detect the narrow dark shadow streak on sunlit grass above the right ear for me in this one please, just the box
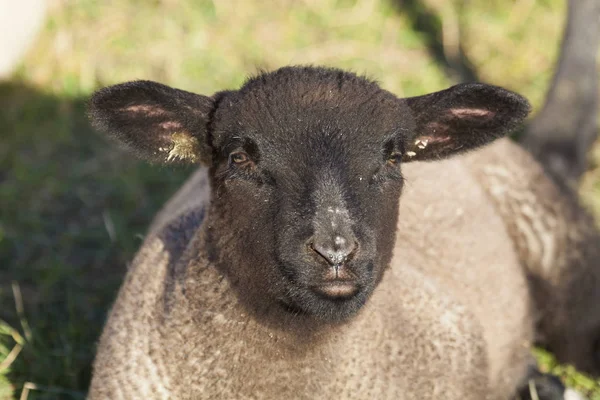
[392,0,479,82]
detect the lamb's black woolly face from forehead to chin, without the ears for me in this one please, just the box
[212,73,414,320]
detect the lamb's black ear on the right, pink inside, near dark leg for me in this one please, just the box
[402,83,530,162]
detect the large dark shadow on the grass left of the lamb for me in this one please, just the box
[0,82,190,400]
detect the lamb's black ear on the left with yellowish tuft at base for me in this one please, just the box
[88,81,213,164]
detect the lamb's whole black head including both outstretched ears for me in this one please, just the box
[90,67,529,321]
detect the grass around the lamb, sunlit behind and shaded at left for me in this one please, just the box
[0,0,600,399]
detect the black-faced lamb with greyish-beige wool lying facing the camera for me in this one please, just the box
[84,66,560,400]
